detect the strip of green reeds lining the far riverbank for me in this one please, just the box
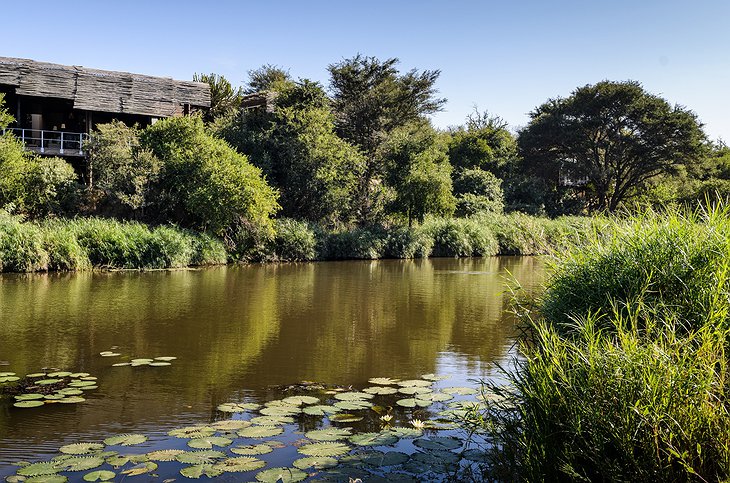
[0,213,605,272]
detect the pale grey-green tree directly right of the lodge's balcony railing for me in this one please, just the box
[87,121,162,218]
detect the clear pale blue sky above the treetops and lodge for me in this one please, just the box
[5,0,730,142]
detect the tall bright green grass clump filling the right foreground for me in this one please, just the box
[474,209,730,481]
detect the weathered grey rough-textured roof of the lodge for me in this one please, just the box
[0,57,210,117]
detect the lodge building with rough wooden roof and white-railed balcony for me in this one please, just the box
[0,57,210,158]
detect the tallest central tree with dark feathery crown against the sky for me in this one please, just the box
[328,54,446,222]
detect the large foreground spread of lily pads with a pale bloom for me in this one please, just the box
[8,374,487,483]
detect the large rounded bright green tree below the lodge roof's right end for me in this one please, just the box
[140,117,279,240]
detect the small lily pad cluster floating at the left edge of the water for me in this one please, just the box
[0,370,98,408]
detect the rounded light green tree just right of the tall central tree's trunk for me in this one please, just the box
[384,122,455,226]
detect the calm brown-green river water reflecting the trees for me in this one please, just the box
[0,257,543,475]
